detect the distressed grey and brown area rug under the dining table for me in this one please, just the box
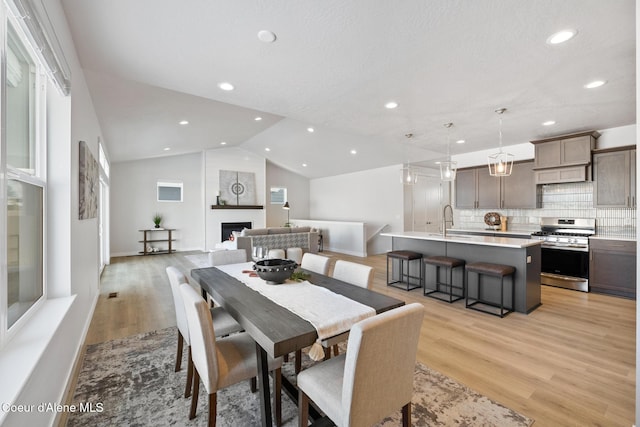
[67,327,533,427]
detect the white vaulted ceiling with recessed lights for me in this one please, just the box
[62,0,636,178]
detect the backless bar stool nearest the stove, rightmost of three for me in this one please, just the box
[465,262,516,317]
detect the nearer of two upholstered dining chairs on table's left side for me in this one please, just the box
[180,284,282,426]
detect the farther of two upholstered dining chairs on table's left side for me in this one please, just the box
[166,266,242,397]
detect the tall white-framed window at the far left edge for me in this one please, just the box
[0,13,46,336]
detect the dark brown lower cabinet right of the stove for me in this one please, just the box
[589,239,636,299]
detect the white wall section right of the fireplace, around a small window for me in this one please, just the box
[265,161,309,227]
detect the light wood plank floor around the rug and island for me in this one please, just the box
[80,252,635,427]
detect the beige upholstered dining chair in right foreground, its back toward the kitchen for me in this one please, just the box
[297,303,424,427]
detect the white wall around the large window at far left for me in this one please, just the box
[2,0,101,426]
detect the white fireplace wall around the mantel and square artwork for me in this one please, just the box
[204,148,266,250]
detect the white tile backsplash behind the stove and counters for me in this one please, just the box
[454,181,636,237]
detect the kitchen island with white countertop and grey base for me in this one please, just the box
[381,231,542,314]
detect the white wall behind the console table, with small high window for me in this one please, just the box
[110,153,204,256]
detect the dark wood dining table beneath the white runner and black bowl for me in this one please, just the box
[191,267,404,426]
